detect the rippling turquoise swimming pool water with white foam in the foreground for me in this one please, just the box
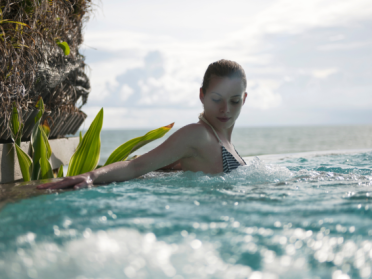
[0,151,372,279]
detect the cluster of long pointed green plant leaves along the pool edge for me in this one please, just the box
[10,97,174,181]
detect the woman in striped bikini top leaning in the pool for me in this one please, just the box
[38,60,247,189]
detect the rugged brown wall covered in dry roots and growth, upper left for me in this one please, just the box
[0,0,92,142]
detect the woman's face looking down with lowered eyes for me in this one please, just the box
[200,76,247,128]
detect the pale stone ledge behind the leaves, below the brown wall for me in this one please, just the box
[0,137,79,184]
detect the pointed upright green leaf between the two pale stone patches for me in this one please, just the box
[31,125,53,180]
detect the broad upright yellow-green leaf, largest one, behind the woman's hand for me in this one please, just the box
[66,108,103,176]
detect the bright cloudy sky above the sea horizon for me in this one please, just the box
[80,0,372,129]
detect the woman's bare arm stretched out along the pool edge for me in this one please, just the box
[37,125,196,189]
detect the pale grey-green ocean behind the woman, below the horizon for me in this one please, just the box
[99,125,372,164]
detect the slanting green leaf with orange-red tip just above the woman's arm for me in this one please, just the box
[105,123,174,166]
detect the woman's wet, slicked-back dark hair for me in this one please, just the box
[202,59,247,94]
